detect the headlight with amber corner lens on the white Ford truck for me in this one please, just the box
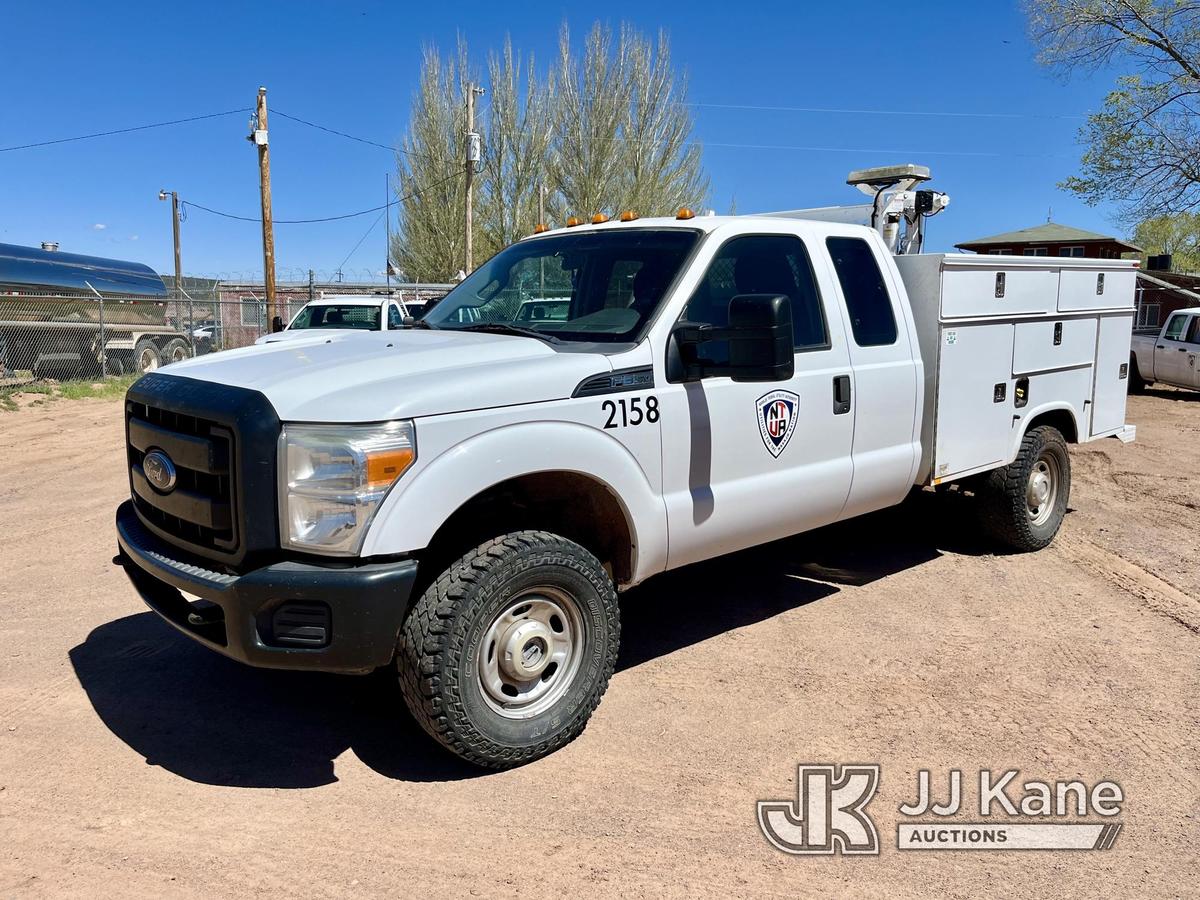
[280,421,416,556]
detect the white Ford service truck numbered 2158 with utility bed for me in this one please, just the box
[116,166,1135,768]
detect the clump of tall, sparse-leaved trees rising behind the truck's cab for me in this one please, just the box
[392,24,708,281]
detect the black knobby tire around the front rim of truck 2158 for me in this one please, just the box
[396,530,620,769]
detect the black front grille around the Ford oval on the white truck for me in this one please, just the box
[126,400,239,553]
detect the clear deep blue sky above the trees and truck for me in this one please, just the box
[0,0,1116,277]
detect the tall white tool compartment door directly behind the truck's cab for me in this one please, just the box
[932,323,1013,479]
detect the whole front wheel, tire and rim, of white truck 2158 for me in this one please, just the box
[396,532,620,769]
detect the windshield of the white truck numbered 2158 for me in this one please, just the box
[425,228,700,341]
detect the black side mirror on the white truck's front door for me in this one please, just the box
[667,294,796,382]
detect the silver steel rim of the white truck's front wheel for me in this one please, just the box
[476,586,583,719]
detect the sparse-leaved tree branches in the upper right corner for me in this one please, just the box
[1025,0,1200,222]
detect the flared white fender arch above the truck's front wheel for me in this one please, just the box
[362,421,667,582]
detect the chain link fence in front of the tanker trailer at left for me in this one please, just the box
[0,278,452,389]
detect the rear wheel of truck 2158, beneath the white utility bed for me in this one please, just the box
[980,425,1070,552]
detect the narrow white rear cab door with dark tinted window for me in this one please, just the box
[826,235,922,518]
